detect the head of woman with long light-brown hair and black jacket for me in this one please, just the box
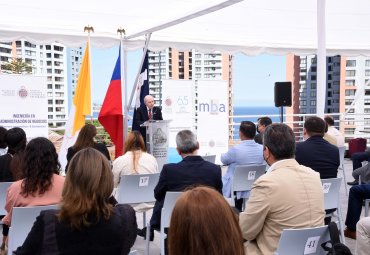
[59,148,113,229]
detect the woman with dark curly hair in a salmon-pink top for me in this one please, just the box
[3,137,64,226]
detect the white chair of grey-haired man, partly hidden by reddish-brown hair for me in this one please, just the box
[159,191,182,254]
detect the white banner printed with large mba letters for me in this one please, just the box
[197,81,229,163]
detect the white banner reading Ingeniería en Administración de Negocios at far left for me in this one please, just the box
[0,75,48,140]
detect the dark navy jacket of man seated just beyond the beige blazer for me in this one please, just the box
[295,136,339,179]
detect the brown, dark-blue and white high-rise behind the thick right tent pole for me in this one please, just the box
[286,55,370,142]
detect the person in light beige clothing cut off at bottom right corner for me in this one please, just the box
[355,217,370,255]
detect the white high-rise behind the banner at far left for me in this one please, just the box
[0,40,82,127]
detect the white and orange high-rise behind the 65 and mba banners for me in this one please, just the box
[148,48,233,138]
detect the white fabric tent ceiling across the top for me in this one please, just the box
[0,0,370,55]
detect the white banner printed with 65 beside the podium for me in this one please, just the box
[162,80,195,148]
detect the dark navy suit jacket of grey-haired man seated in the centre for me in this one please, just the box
[150,156,222,228]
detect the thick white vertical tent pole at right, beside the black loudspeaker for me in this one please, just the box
[316,0,326,117]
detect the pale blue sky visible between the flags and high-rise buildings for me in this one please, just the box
[91,47,286,106]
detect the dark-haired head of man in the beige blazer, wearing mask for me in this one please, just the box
[263,123,295,165]
